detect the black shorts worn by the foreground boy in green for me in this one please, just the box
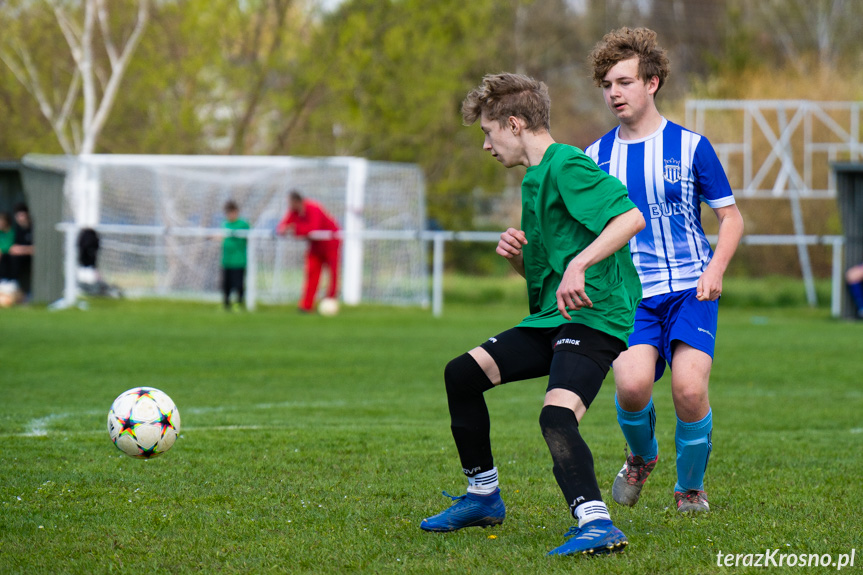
[480,323,626,406]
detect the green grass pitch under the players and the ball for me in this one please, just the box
[0,281,863,574]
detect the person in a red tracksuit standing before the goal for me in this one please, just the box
[276,190,341,311]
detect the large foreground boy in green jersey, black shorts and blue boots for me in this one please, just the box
[420,74,645,555]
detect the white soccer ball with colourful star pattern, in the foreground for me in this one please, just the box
[108,387,180,459]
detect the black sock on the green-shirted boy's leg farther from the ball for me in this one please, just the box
[539,405,602,517]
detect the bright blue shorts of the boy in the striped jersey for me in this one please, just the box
[629,288,719,381]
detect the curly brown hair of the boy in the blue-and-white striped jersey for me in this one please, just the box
[588,27,669,92]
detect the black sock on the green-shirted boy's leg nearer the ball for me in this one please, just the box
[444,353,494,477]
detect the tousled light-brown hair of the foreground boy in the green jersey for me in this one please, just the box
[461,73,551,132]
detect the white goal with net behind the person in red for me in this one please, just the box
[28,155,429,307]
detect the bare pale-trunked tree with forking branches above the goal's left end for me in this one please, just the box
[0,0,150,154]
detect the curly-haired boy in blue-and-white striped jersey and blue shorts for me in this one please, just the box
[585,28,743,512]
